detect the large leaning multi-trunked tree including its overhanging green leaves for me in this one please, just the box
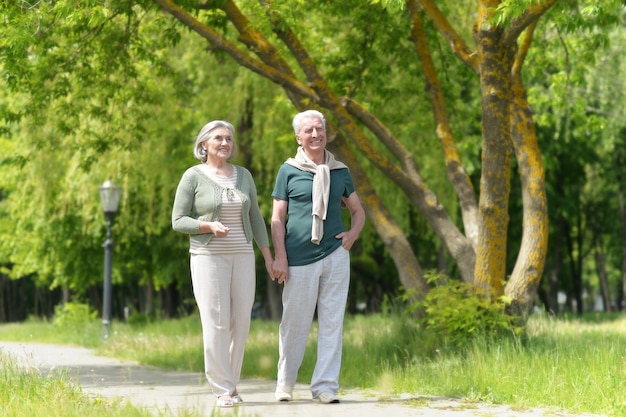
[2,0,620,315]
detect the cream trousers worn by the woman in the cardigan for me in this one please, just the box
[190,253,256,397]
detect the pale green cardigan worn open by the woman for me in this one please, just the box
[172,165,269,248]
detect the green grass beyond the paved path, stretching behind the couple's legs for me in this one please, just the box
[0,314,626,416]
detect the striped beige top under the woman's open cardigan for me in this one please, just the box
[189,164,254,255]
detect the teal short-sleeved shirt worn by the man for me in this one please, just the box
[272,164,354,266]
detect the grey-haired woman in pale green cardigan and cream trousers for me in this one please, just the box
[172,120,272,407]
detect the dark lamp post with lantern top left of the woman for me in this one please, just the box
[100,181,122,340]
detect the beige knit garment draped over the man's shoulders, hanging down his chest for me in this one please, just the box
[285,146,347,245]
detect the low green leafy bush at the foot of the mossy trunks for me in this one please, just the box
[403,272,523,350]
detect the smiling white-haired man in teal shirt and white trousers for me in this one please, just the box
[271,110,365,404]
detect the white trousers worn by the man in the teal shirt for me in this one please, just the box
[277,246,350,398]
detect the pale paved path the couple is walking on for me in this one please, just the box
[0,341,598,417]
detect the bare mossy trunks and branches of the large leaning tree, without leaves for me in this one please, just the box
[147,0,555,314]
